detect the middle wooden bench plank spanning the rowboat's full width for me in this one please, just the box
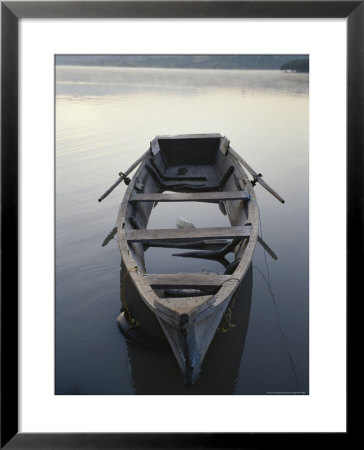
[125,226,251,242]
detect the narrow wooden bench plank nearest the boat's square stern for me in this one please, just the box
[130,191,249,202]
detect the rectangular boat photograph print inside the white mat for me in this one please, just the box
[55,54,309,395]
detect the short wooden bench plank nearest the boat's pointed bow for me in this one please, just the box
[143,273,232,289]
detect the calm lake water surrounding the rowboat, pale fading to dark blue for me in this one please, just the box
[56,66,309,395]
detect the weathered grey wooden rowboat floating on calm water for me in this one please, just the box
[111,134,282,385]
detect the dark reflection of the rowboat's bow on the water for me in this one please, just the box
[122,266,252,395]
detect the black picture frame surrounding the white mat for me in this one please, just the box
[1,0,356,449]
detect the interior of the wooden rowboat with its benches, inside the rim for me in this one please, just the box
[124,135,251,298]
